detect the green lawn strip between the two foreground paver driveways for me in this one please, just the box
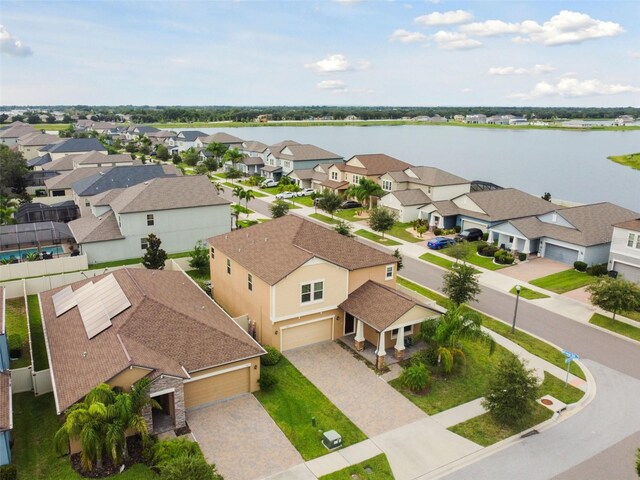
[254,357,367,460]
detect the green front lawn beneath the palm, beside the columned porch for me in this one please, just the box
[389,341,507,415]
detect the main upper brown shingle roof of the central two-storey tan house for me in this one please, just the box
[209,215,397,285]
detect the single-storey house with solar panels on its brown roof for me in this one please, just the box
[39,268,265,436]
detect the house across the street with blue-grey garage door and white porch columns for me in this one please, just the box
[489,202,640,268]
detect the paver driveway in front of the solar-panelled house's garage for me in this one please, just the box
[187,394,303,480]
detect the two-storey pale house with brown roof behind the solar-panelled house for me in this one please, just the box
[68,174,231,264]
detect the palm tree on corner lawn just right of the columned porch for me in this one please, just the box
[420,305,496,373]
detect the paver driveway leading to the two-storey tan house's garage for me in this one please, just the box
[285,342,425,437]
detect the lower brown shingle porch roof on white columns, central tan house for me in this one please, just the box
[340,280,440,332]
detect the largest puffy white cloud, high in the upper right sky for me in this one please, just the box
[460,10,624,46]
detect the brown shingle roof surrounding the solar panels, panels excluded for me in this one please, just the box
[40,268,264,413]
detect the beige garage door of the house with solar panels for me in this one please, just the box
[184,367,249,408]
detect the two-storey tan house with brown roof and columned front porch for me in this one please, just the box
[209,215,440,366]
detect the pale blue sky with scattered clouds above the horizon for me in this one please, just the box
[0,0,640,107]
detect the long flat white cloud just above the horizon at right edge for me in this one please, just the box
[512,78,640,99]
